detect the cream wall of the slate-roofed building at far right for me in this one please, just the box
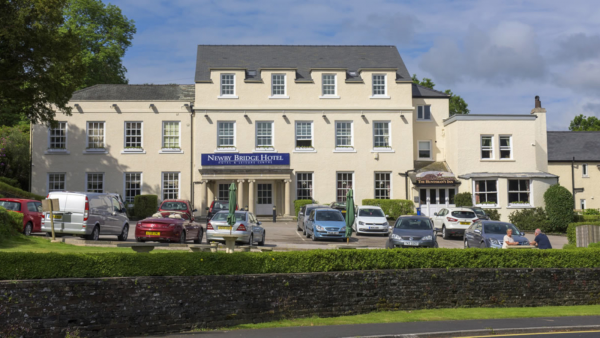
[548,162,600,209]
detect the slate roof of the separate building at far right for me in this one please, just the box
[548,131,600,162]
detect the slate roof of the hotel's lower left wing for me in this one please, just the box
[71,84,195,101]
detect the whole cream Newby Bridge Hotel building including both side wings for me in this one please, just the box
[32,45,592,220]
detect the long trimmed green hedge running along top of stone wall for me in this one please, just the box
[0,249,600,280]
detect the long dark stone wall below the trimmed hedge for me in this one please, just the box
[0,269,600,337]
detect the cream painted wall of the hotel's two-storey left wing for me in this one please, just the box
[32,101,191,199]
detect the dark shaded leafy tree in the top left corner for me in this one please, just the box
[0,0,85,123]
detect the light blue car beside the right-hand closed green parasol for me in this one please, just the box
[305,209,346,241]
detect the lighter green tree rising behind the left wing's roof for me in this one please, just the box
[62,0,136,89]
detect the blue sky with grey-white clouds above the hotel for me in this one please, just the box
[108,0,600,130]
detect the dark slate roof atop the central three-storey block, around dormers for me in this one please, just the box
[195,45,411,82]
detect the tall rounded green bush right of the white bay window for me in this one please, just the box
[544,184,573,232]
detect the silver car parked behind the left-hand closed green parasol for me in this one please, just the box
[206,211,267,246]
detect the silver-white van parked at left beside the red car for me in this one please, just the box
[42,191,129,241]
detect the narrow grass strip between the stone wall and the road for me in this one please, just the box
[227,305,600,330]
